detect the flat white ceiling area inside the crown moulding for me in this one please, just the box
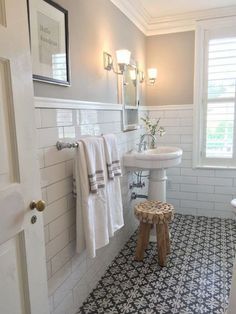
[137,0,236,18]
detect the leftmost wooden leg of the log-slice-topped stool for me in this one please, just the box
[135,222,151,261]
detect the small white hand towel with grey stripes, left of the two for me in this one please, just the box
[81,137,105,193]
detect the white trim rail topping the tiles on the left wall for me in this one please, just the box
[34,97,123,111]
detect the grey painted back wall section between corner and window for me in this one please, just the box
[146,32,195,106]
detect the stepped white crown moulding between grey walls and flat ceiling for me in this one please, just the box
[110,0,236,36]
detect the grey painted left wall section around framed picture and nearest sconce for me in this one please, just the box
[34,0,146,104]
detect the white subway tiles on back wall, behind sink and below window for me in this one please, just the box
[142,106,236,218]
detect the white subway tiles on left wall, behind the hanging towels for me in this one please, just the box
[35,108,140,314]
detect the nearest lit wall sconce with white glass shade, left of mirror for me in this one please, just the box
[103,49,131,75]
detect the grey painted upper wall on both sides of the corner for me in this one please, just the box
[34,0,194,106]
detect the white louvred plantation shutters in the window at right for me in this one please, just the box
[202,28,236,164]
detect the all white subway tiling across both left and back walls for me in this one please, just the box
[35,102,236,314]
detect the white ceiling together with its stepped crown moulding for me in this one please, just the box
[110,0,236,36]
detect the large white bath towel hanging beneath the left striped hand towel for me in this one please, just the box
[75,142,109,257]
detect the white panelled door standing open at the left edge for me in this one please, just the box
[0,0,48,314]
